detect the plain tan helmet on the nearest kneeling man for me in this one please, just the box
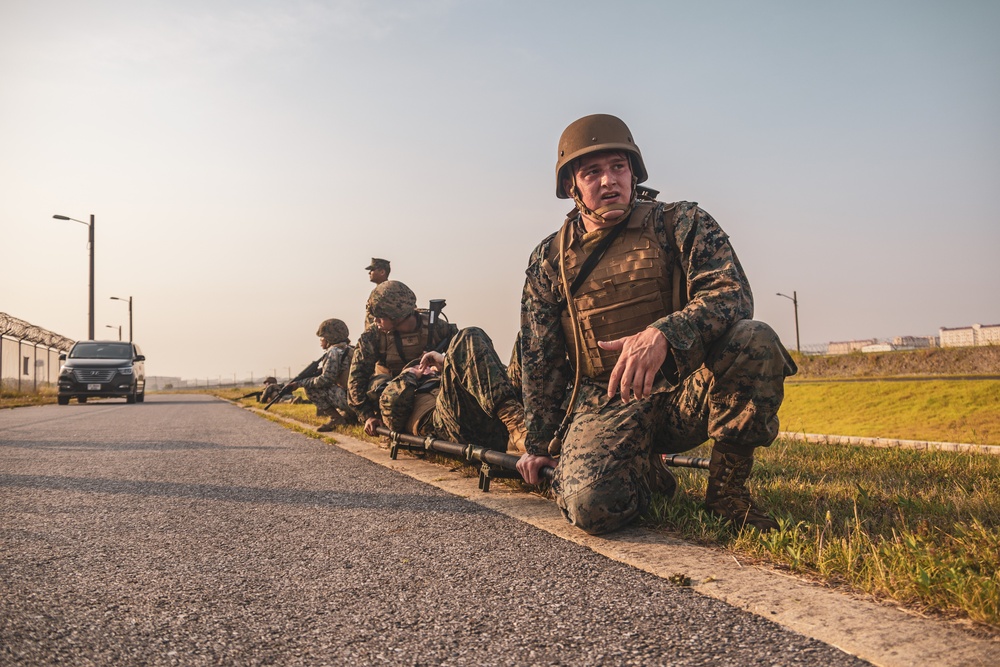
[556,113,649,199]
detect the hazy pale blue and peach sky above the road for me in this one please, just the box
[0,0,1000,381]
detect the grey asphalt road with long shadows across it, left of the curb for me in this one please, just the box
[0,395,868,666]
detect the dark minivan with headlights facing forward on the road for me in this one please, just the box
[59,340,146,405]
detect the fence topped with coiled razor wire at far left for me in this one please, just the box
[0,313,75,391]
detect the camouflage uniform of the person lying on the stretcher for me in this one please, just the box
[379,327,518,452]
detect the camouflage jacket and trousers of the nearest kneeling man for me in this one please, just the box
[521,202,795,533]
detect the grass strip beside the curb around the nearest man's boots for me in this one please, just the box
[644,440,1000,632]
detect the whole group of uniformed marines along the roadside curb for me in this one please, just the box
[252,114,796,534]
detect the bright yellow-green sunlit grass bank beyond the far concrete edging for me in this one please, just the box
[778,380,1000,445]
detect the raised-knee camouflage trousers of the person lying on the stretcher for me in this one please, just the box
[433,327,517,452]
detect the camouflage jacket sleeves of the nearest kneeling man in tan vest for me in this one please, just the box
[521,202,753,454]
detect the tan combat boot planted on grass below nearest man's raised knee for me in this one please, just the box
[705,449,778,532]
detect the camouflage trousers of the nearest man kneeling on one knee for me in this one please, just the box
[552,320,796,534]
